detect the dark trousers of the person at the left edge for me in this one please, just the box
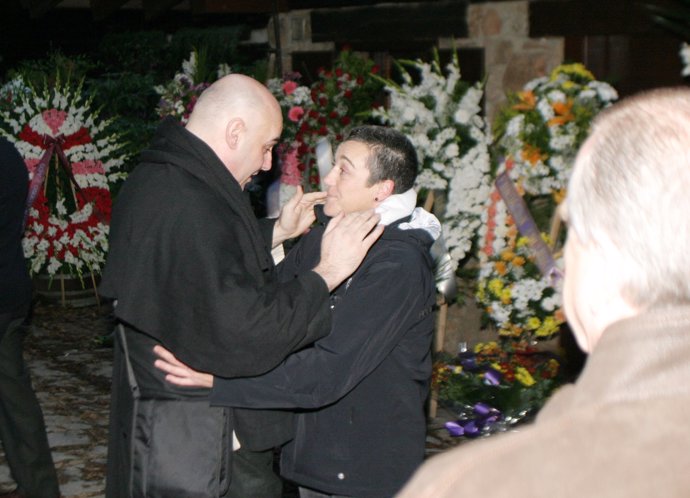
[0,308,60,498]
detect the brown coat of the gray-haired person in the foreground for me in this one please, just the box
[398,307,690,498]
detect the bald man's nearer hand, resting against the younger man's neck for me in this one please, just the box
[314,210,384,291]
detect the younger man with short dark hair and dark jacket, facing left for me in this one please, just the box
[156,126,441,498]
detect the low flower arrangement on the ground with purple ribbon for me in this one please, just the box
[432,341,562,438]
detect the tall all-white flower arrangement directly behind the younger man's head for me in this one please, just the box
[373,50,490,268]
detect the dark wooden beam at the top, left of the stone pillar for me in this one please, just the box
[311,0,469,50]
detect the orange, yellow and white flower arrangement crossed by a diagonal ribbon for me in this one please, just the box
[477,64,617,341]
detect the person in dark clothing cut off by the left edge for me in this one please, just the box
[0,138,60,498]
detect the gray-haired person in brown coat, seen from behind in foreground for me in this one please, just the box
[398,88,690,498]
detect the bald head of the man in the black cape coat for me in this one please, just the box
[187,74,283,187]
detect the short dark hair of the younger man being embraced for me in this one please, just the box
[345,125,418,194]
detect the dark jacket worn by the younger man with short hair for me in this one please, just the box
[211,210,435,497]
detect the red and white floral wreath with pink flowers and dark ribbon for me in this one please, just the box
[0,77,126,277]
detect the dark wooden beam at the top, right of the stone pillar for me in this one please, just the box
[529,0,654,38]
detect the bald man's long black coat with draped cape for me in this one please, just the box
[101,120,330,497]
